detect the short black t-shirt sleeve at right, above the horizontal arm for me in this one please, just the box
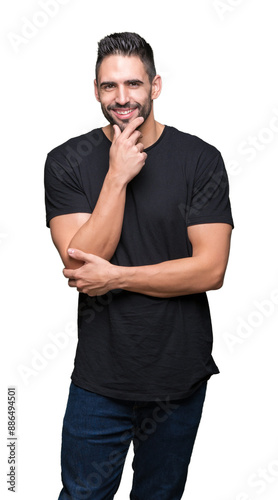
[187,150,234,227]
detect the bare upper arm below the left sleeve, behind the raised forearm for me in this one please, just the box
[50,212,91,265]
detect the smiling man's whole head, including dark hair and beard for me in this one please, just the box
[95,33,161,130]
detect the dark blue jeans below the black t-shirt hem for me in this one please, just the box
[58,382,207,500]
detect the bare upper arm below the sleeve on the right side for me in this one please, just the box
[187,223,232,278]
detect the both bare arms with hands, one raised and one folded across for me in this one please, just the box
[50,118,232,297]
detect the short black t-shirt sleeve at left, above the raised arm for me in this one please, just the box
[44,154,92,227]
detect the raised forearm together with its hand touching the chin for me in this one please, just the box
[63,116,147,268]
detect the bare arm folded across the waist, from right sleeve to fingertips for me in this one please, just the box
[51,219,232,298]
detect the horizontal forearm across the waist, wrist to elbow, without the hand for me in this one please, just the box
[118,257,223,298]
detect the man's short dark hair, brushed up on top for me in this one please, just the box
[96,32,156,83]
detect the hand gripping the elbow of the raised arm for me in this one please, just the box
[63,248,120,297]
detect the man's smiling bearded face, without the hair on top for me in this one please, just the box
[95,55,152,131]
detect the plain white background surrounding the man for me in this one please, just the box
[0,0,278,500]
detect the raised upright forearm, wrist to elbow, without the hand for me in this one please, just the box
[68,172,126,260]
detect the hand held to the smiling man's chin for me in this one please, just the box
[109,116,147,184]
